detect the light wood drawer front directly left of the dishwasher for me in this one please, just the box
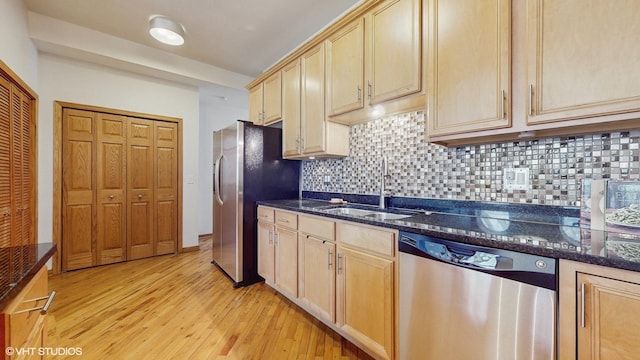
[336,222,396,257]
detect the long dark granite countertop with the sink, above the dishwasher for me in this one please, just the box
[259,199,640,271]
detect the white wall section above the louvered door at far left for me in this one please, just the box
[0,0,38,92]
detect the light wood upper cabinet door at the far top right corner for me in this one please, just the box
[526,0,640,124]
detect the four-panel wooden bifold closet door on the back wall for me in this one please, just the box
[62,108,179,271]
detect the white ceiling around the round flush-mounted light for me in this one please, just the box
[23,0,360,78]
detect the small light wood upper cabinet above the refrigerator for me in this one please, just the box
[249,71,282,125]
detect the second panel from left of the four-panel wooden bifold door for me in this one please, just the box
[96,113,127,265]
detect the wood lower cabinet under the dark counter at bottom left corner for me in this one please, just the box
[0,266,48,359]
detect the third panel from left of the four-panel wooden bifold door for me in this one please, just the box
[127,118,155,260]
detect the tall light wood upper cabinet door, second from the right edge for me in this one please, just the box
[427,0,511,135]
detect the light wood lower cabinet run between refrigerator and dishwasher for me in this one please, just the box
[258,206,397,359]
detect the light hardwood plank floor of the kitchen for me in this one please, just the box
[48,239,370,359]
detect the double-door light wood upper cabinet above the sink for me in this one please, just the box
[326,0,424,124]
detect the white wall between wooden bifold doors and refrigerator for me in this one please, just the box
[198,88,249,234]
